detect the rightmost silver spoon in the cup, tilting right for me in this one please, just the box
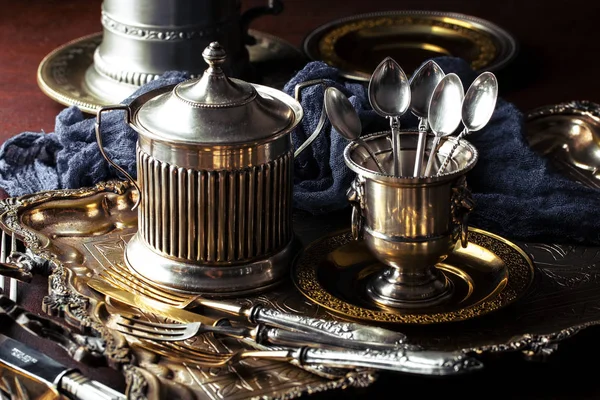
[437,72,498,175]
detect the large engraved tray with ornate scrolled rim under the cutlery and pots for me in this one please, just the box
[0,181,600,399]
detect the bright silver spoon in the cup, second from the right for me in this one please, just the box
[425,73,465,176]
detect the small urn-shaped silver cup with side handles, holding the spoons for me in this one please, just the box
[344,132,478,309]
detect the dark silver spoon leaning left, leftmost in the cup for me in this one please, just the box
[323,87,385,174]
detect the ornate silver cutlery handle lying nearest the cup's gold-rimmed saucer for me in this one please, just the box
[248,304,407,349]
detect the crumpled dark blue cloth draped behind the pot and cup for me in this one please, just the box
[0,57,600,245]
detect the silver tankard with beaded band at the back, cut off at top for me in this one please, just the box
[84,0,283,104]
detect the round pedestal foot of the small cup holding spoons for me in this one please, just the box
[366,267,453,310]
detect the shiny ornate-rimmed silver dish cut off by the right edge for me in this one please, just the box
[525,101,600,189]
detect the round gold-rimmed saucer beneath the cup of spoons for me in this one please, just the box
[292,228,534,324]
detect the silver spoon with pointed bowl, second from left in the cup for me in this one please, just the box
[369,57,410,176]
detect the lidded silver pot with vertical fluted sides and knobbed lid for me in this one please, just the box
[96,42,318,296]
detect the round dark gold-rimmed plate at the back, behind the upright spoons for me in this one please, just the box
[303,11,518,81]
